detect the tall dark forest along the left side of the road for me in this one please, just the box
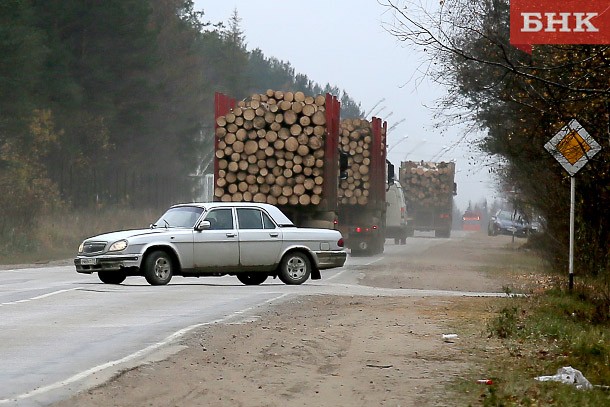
[0,0,363,252]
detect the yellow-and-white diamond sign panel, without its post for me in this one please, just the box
[544,119,602,176]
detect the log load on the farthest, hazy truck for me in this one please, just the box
[399,161,455,206]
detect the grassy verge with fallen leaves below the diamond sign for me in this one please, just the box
[436,241,610,406]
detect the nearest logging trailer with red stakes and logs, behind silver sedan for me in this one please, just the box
[214,89,340,229]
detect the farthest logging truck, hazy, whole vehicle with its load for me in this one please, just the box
[399,161,457,238]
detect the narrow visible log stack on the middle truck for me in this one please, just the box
[338,119,385,205]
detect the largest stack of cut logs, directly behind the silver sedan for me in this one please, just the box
[214,89,327,205]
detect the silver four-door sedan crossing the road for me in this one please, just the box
[74,202,347,285]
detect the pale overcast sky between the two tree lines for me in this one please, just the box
[195,0,496,210]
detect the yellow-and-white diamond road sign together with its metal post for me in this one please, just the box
[544,119,602,291]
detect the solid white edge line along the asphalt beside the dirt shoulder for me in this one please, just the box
[0,290,290,404]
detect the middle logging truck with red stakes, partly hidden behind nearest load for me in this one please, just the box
[338,117,394,254]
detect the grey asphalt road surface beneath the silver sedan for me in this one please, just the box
[0,234,499,406]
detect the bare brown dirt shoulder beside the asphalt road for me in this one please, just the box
[54,233,528,407]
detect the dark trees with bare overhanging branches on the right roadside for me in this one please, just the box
[383,0,610,286]
